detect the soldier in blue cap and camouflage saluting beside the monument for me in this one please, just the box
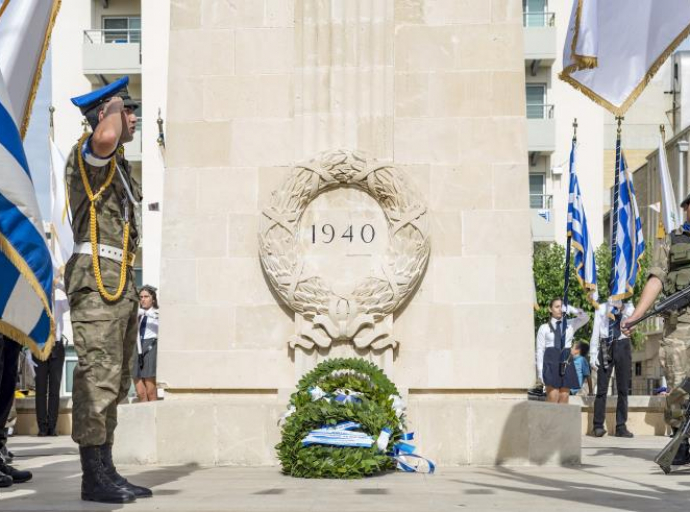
[65,77,152,503]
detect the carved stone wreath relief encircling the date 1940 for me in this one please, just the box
[259,150,430,350]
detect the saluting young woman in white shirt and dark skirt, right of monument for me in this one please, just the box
[537,299,589,404]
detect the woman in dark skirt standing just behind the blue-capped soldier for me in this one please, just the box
[132,285,158,402]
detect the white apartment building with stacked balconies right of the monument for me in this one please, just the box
[523,0,604,245]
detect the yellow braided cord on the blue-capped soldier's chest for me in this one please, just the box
[77,133,129,302]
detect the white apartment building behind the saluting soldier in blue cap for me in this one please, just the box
[51,0,170,292]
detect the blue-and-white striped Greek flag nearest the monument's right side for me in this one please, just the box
[568,141,599,307]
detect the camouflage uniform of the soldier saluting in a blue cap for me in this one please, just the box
[65,144,141,446]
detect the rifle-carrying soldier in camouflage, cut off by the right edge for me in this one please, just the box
[621,195,690,465]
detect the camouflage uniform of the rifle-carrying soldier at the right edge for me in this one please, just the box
[649,228,690,427]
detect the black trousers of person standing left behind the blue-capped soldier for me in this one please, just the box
[36,343,65,433]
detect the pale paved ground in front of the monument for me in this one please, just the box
[0,437,690,512]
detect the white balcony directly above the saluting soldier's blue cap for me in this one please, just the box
[82,29,141,85]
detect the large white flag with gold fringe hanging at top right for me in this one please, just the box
[560,0,690,115]
